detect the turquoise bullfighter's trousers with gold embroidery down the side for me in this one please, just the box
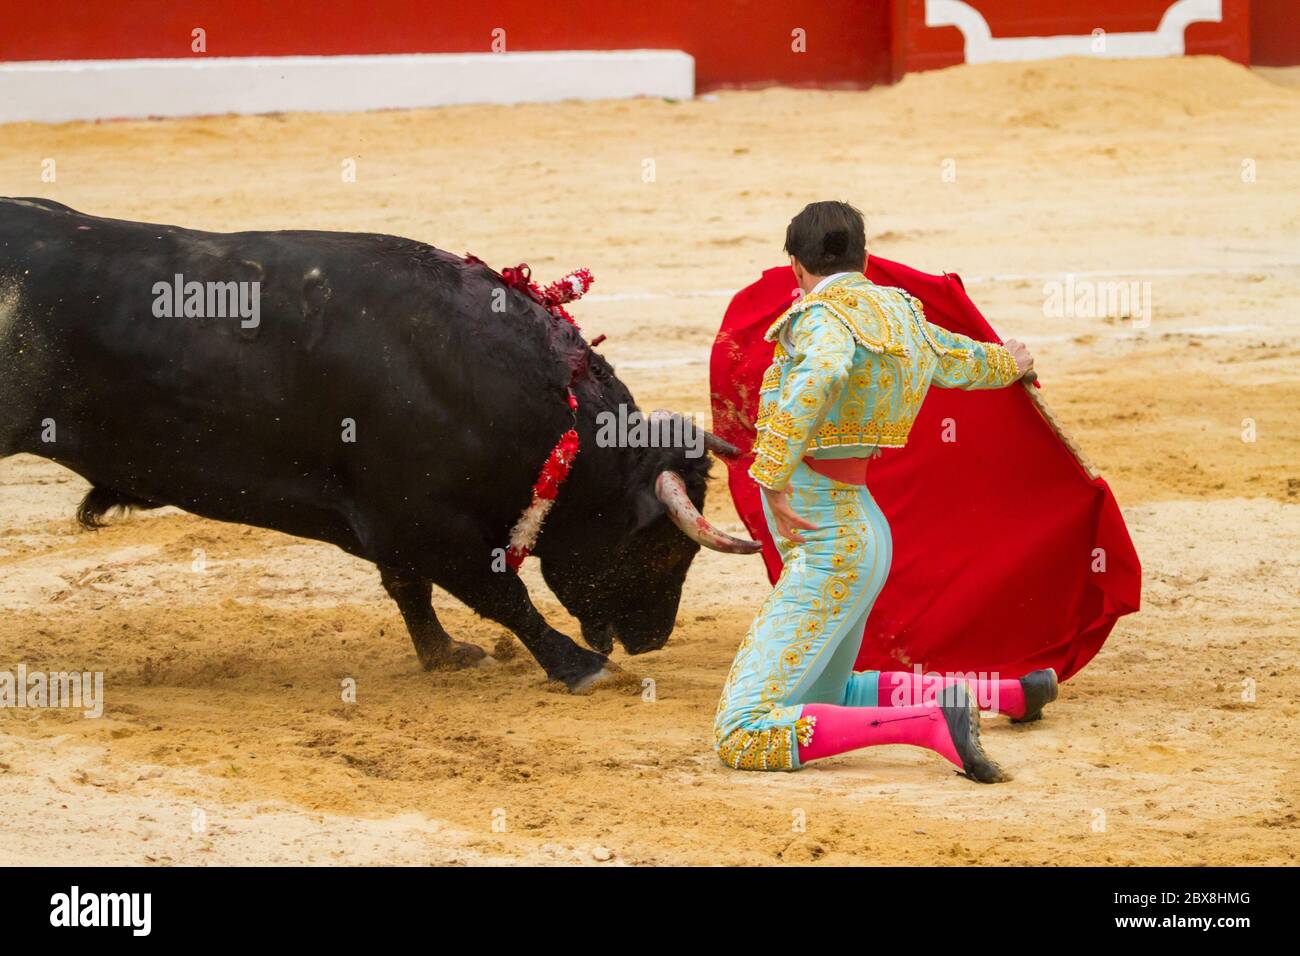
[714,462,893,770]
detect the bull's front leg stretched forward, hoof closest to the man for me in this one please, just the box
[434,567,616,693]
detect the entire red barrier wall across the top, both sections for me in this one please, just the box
[0,0,1279,90]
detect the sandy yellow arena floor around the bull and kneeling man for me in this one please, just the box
[0,59,1300,865]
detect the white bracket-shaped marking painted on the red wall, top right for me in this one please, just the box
[926,0,1223,62]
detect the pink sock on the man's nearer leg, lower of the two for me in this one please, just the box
[800,704,962,767]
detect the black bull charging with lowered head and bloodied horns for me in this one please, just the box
[0,199,751,689]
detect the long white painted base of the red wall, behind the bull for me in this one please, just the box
[0,49,696,122]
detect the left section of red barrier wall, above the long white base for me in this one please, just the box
[0,0,891,90]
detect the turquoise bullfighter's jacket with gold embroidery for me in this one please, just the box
[749,273,1021,490]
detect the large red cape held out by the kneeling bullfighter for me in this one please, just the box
[710,256,1141,680]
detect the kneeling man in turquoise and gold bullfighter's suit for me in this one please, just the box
[715,202,1057,783]
